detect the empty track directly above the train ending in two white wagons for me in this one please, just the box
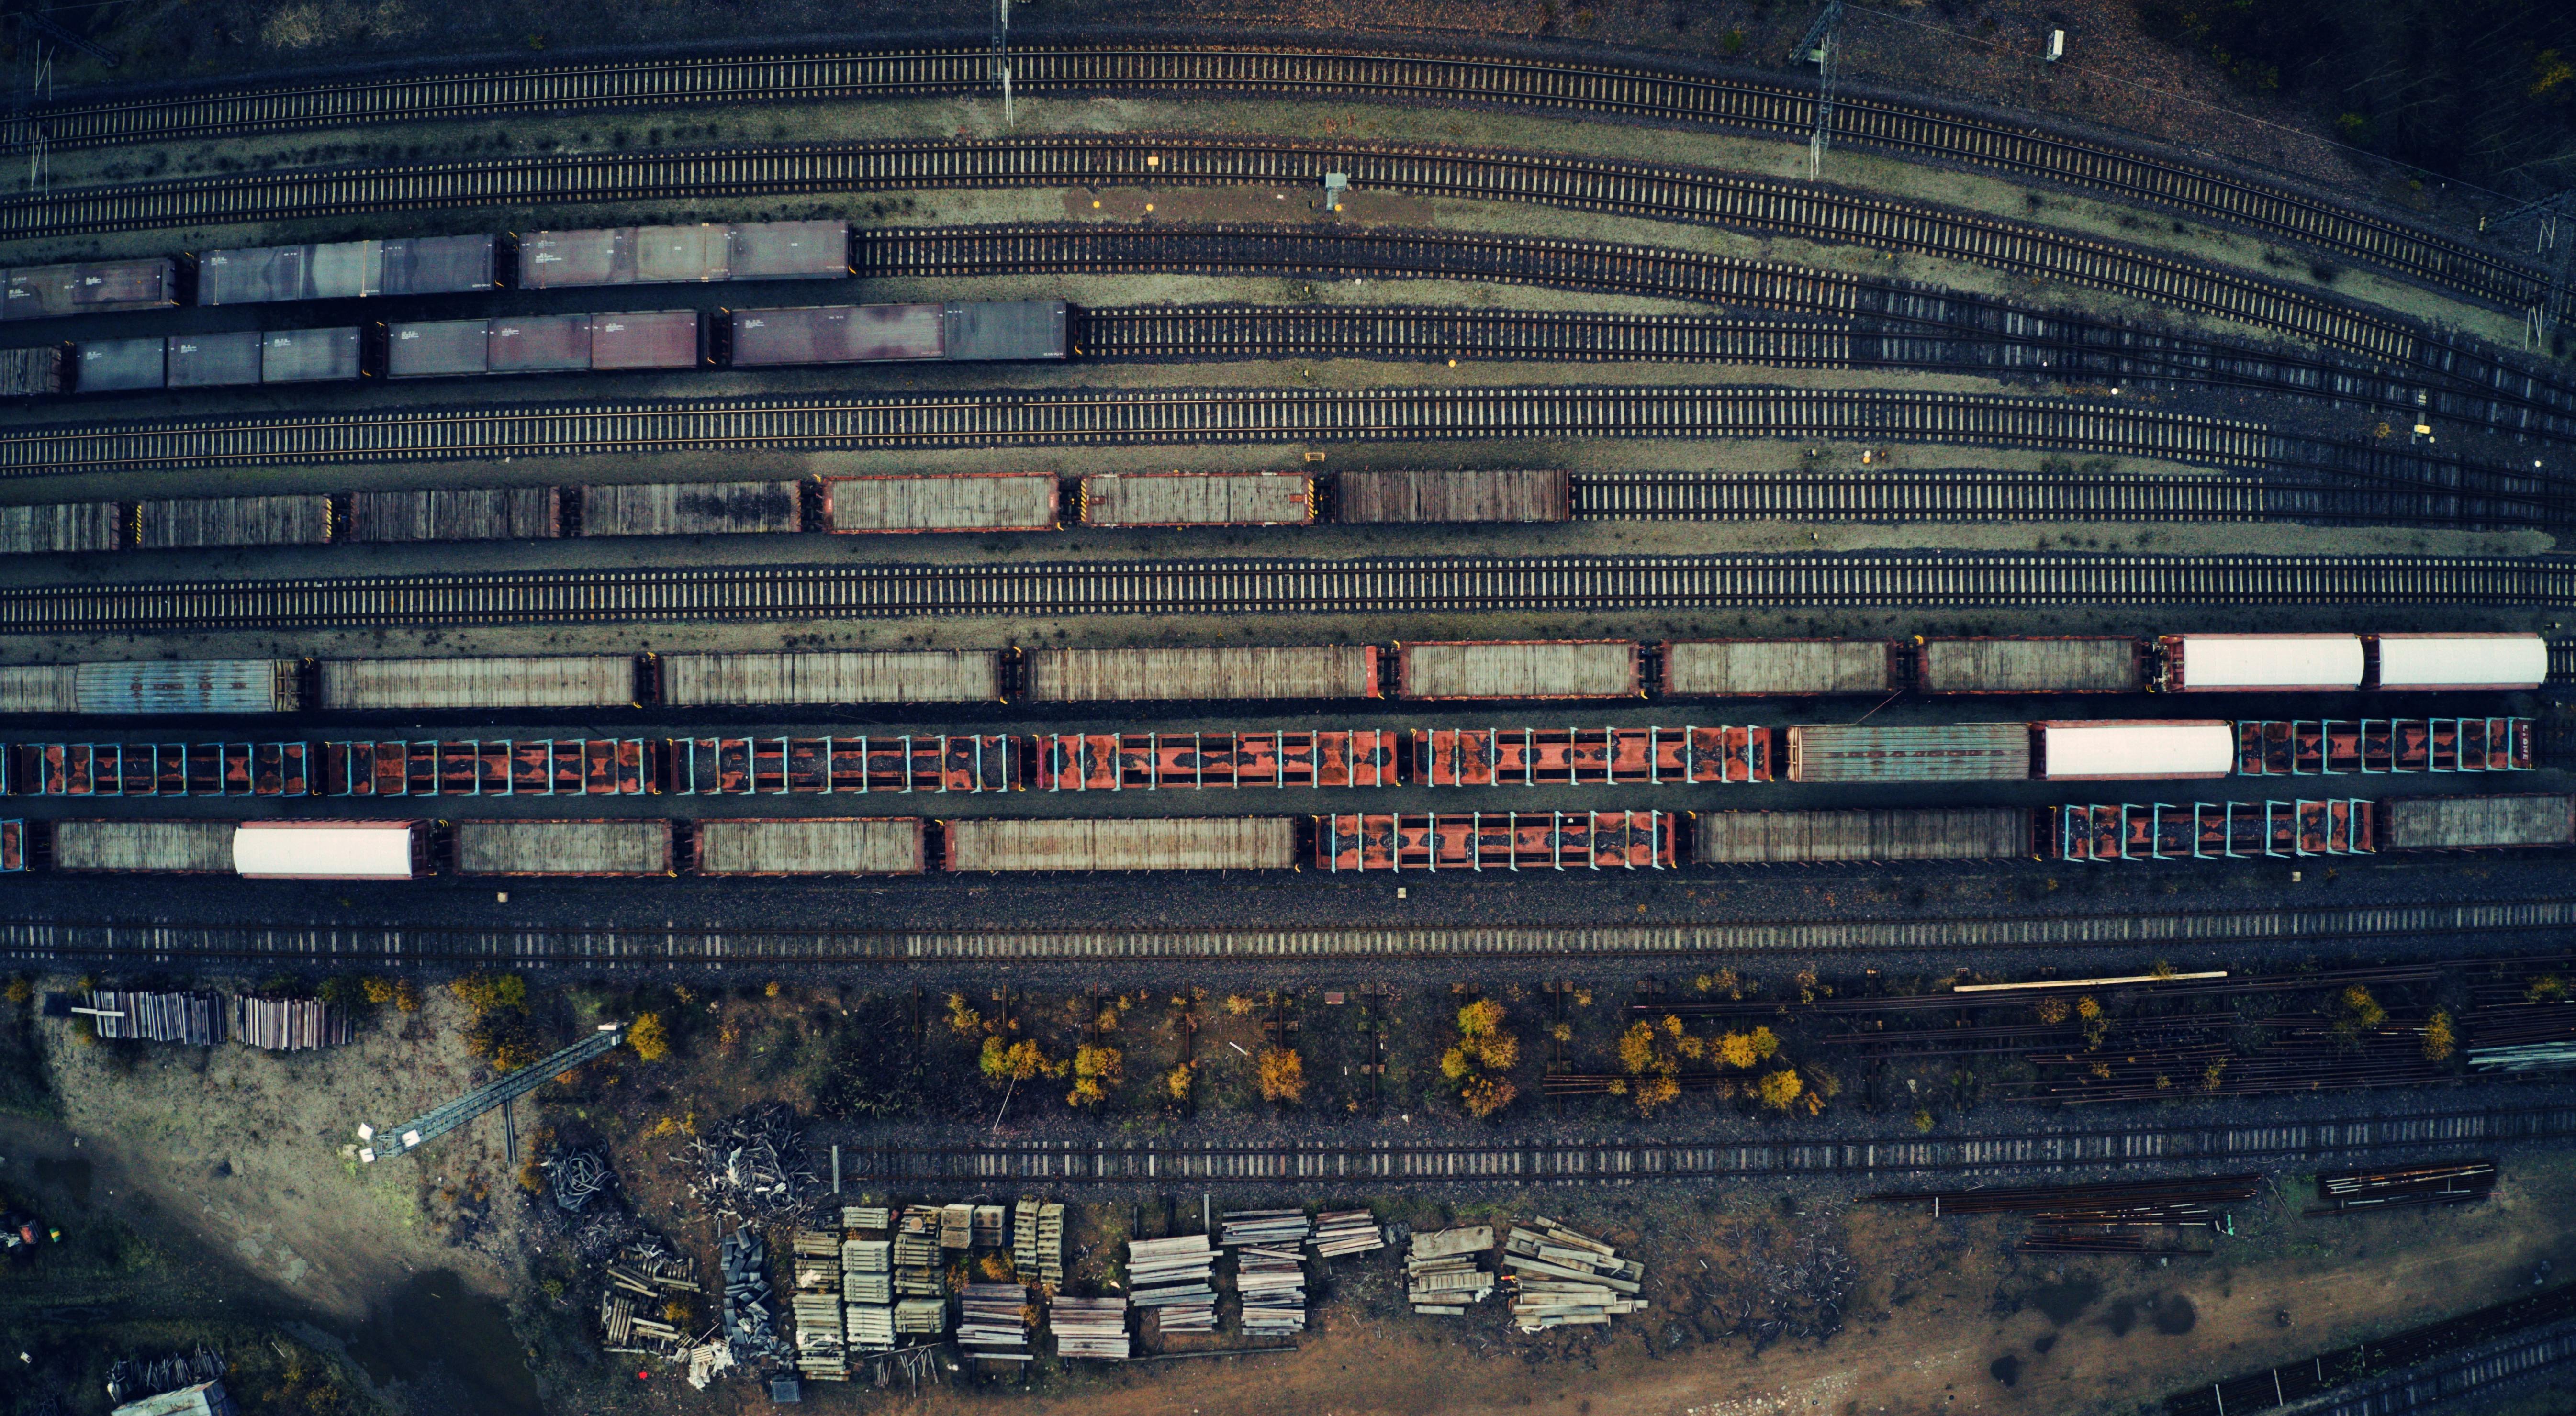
[0,554,2576,633]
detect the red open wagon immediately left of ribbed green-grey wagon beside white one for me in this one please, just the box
[1409,726,1772,788]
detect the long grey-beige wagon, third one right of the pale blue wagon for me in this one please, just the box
[1028,644,1378,703]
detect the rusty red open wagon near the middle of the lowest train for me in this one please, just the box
[1314,811,1680,873]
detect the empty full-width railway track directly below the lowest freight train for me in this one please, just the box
[0,899,2576,970]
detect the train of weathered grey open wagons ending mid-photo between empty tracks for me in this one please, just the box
[0,471,1571,566]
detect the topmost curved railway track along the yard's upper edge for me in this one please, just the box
[0,44,2548,309]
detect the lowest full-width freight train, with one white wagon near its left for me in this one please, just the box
[0,793,2576,881]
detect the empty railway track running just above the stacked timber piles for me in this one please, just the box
[842,1107,2576,1187]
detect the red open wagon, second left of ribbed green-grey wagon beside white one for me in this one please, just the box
[1030,729,1396,791]
